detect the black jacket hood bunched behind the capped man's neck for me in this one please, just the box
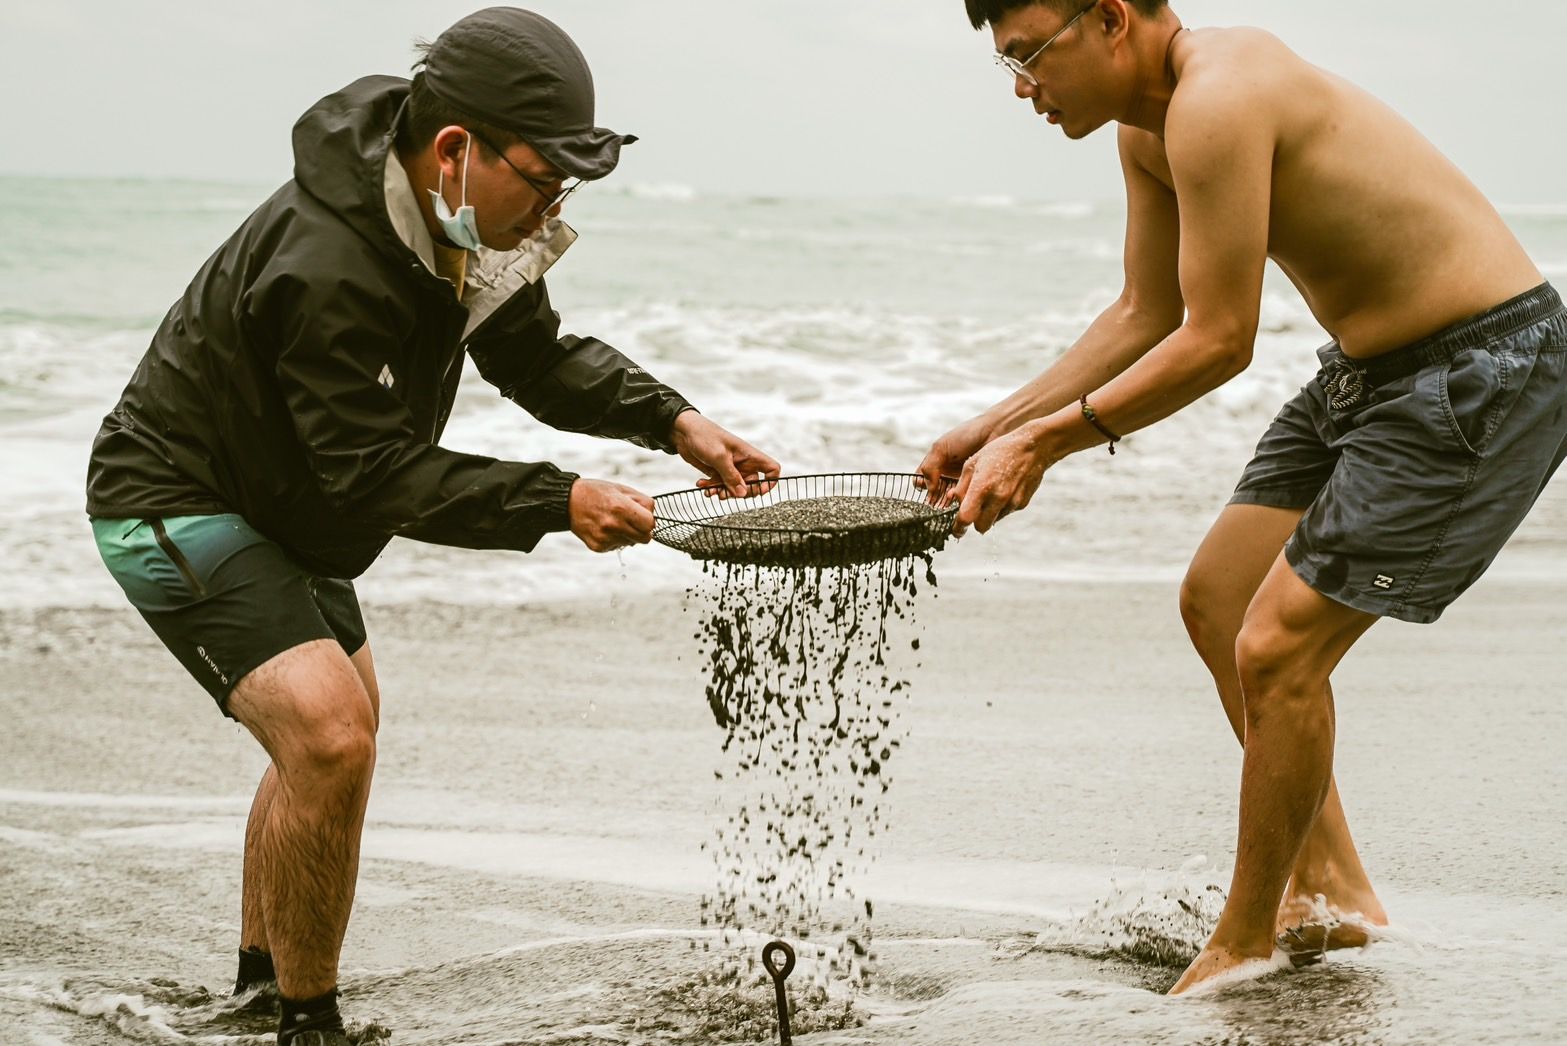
[293,77,411,255]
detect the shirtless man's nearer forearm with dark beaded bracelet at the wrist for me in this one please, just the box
[1028,326,1252,460]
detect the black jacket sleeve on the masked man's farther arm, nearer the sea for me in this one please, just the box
[469,280,696,454]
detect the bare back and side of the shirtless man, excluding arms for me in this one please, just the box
[1122,28,1543,355]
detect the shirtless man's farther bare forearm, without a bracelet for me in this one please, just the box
[984,298,1178,438]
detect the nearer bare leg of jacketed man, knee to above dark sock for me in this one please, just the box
[229,639,376,999]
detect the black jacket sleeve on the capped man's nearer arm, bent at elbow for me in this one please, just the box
[265,267,577,551]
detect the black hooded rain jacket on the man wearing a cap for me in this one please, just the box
[88,77,689,578]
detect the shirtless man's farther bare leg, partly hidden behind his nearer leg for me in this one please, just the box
[1182,504,1387,947]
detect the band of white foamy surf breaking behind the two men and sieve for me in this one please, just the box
[21,291,1567,606]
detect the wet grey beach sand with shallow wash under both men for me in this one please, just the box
[0,576,1567,1046]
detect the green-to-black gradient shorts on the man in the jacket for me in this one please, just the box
[92,514,365,719]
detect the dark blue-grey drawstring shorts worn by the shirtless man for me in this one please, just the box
[1230,283,1567,623]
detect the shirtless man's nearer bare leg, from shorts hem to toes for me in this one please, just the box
[1171,554,1377,994]
